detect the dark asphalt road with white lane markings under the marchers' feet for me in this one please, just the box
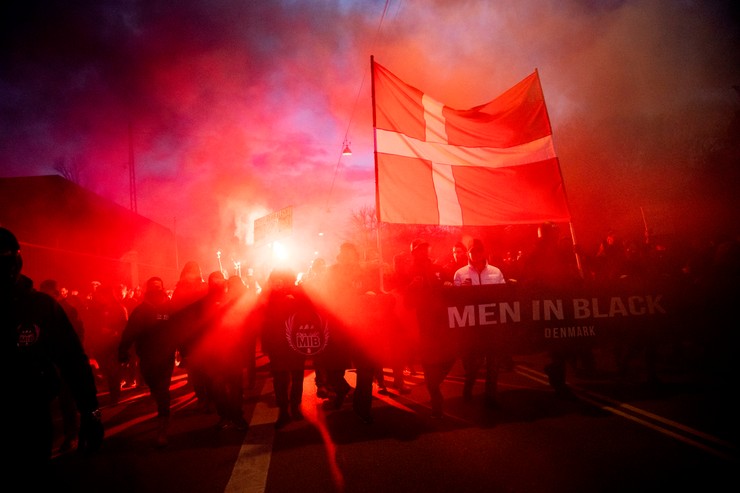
[49,346,740,493]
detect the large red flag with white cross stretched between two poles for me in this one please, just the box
[371,58,570,226]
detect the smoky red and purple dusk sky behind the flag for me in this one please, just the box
[0,0,740,270]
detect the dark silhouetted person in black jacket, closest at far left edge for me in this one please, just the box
[0,228,104,484]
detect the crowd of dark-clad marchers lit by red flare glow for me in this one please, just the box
[0,224,739,484]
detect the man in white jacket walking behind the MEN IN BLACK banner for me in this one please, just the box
[453,238,506,408]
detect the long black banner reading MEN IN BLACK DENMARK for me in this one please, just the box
[422,283,695,354]
